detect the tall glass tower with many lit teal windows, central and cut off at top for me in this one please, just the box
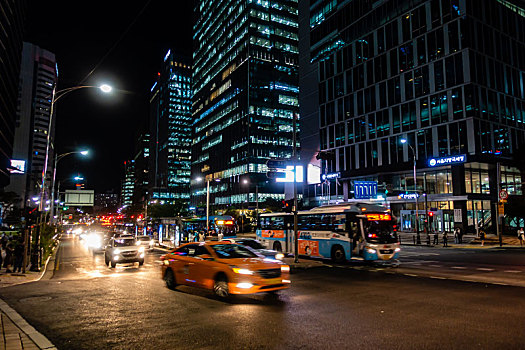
[192,0,299,208]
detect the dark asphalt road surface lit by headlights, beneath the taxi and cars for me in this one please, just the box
[0,240,525,349]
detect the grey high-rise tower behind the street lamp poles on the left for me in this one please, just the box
[8,42,58,206]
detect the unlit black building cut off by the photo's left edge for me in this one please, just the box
[0,0,27,189]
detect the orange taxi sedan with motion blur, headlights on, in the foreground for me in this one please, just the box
[161,241,290,298]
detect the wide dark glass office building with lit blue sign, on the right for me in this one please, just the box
[310,0,525,230]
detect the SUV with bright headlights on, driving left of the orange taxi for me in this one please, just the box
[104,237,146,267]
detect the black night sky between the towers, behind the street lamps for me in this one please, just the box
[25,0,193,193]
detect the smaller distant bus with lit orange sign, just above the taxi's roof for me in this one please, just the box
[182,215,237,238]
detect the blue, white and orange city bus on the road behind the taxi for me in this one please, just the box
[256,203,401,262]
